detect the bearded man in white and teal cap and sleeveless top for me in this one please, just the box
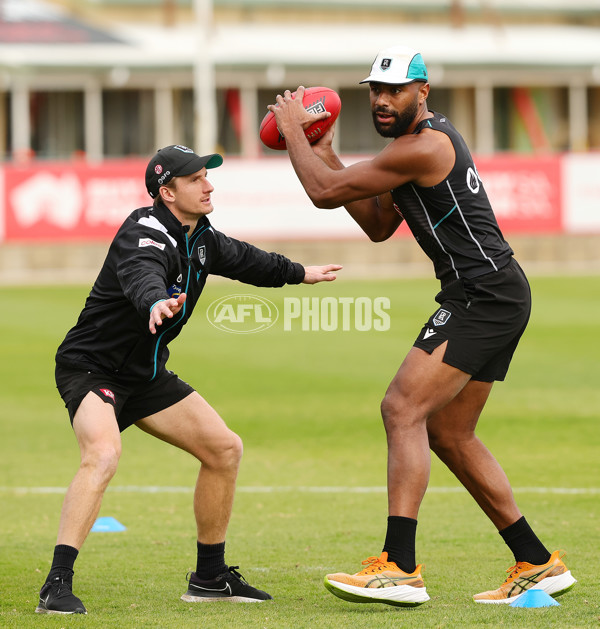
[269,46,575,606]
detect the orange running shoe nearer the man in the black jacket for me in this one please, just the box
[324,552,429,607]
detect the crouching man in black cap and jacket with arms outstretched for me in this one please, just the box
[36,145,341,614]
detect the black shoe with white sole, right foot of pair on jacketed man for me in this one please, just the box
[181,566,273,603]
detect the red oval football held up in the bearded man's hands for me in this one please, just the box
[259,87,342,151]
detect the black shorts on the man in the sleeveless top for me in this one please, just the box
[414,259,531,382]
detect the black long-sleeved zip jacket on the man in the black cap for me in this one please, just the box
[56,203,305,381]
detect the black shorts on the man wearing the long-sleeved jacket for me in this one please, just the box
[55,364,194,432]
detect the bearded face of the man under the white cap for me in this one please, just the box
[369,82,422,138]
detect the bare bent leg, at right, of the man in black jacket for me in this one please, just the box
[136,392,243,544]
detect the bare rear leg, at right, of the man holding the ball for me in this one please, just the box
[427,381,521,530]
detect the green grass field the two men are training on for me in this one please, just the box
[0,275,600,629]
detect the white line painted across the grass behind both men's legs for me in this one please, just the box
[0,485,600,495]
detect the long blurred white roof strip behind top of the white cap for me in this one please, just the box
[0,23,600,69]
